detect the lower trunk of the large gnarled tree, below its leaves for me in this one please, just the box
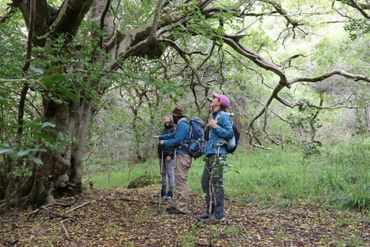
[26,97,95,206]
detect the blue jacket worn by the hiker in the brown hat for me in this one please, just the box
[159,118,190,154]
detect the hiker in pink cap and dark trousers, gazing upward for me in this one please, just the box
[197,93,234,223]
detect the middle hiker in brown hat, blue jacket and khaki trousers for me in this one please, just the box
[159,107,191,214]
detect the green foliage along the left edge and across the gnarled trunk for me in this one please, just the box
[0,9,112,183]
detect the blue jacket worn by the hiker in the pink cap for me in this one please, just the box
[204,111,234,156]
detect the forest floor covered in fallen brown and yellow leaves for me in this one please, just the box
[0,185,370,246]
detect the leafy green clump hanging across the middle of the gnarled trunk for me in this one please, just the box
[31,29,109,104]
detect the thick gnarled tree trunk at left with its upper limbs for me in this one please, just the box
[0,0,171,209]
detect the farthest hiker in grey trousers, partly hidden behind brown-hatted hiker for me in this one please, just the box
[158,113,175,201]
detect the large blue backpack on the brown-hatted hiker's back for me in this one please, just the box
[188,117,205,159]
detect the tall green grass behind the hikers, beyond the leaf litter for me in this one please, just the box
[84,138,370,210]
